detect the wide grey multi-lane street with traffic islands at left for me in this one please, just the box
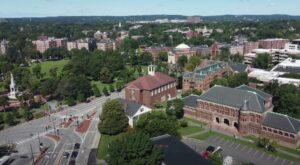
[0,91,124,165]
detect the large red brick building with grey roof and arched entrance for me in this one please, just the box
[184,85,300,146]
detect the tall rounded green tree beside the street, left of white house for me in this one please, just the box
[98,99,128,135]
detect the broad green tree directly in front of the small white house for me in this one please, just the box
[135,112,180,137]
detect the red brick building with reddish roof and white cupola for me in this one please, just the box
[125,65,177,107]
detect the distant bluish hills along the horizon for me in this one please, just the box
[4,15,300,23]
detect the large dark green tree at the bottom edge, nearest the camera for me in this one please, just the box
[106,132,162,165]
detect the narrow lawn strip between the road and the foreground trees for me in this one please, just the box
[97,133,124,160]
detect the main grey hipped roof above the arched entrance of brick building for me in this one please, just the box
[199,85,265,113]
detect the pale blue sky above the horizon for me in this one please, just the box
[0,0,300,17]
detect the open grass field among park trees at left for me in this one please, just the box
[30,60,70,77]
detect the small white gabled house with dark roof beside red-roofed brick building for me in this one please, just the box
[119,98,152,127]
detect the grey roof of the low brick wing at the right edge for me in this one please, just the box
[262,112,300,134]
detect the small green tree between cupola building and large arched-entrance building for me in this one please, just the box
[166,99,184,119]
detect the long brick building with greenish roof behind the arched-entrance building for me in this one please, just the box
[182,60,232,92]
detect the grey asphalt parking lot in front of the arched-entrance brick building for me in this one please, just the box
[183,137,299,165]
